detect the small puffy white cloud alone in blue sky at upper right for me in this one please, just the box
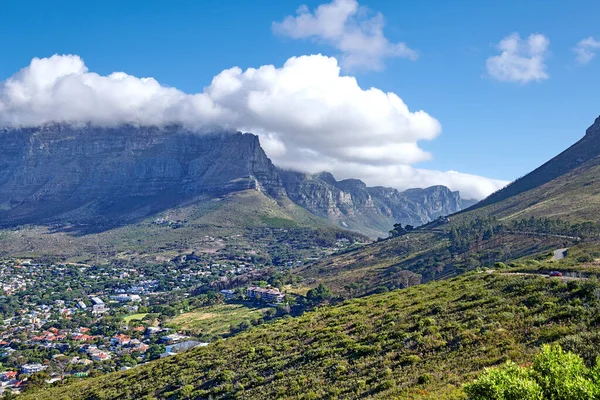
[486,33,550,83]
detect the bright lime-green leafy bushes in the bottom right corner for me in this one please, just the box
[464,345,600,400]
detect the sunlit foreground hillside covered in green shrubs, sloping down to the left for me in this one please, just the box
[20,271,600,400]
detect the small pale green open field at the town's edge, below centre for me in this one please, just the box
[169,304,267,336]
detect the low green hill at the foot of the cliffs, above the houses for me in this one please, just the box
[0,190,368,263]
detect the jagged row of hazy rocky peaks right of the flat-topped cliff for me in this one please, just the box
[279,170,473,237]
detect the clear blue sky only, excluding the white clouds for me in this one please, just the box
[0,0,600,198]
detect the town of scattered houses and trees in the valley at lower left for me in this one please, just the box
[0,236,350,393]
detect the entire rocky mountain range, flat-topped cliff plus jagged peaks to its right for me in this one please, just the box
[0,125,473,237]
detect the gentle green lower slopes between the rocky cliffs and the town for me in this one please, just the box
[0,190,366,262]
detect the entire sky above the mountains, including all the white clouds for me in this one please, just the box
[0,0,600,199]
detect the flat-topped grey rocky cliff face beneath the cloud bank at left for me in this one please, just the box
[0,125,284,225]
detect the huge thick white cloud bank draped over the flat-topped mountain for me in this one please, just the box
[0,55,506,198]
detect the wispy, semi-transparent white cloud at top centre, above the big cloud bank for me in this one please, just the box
[273,0,418,70]
